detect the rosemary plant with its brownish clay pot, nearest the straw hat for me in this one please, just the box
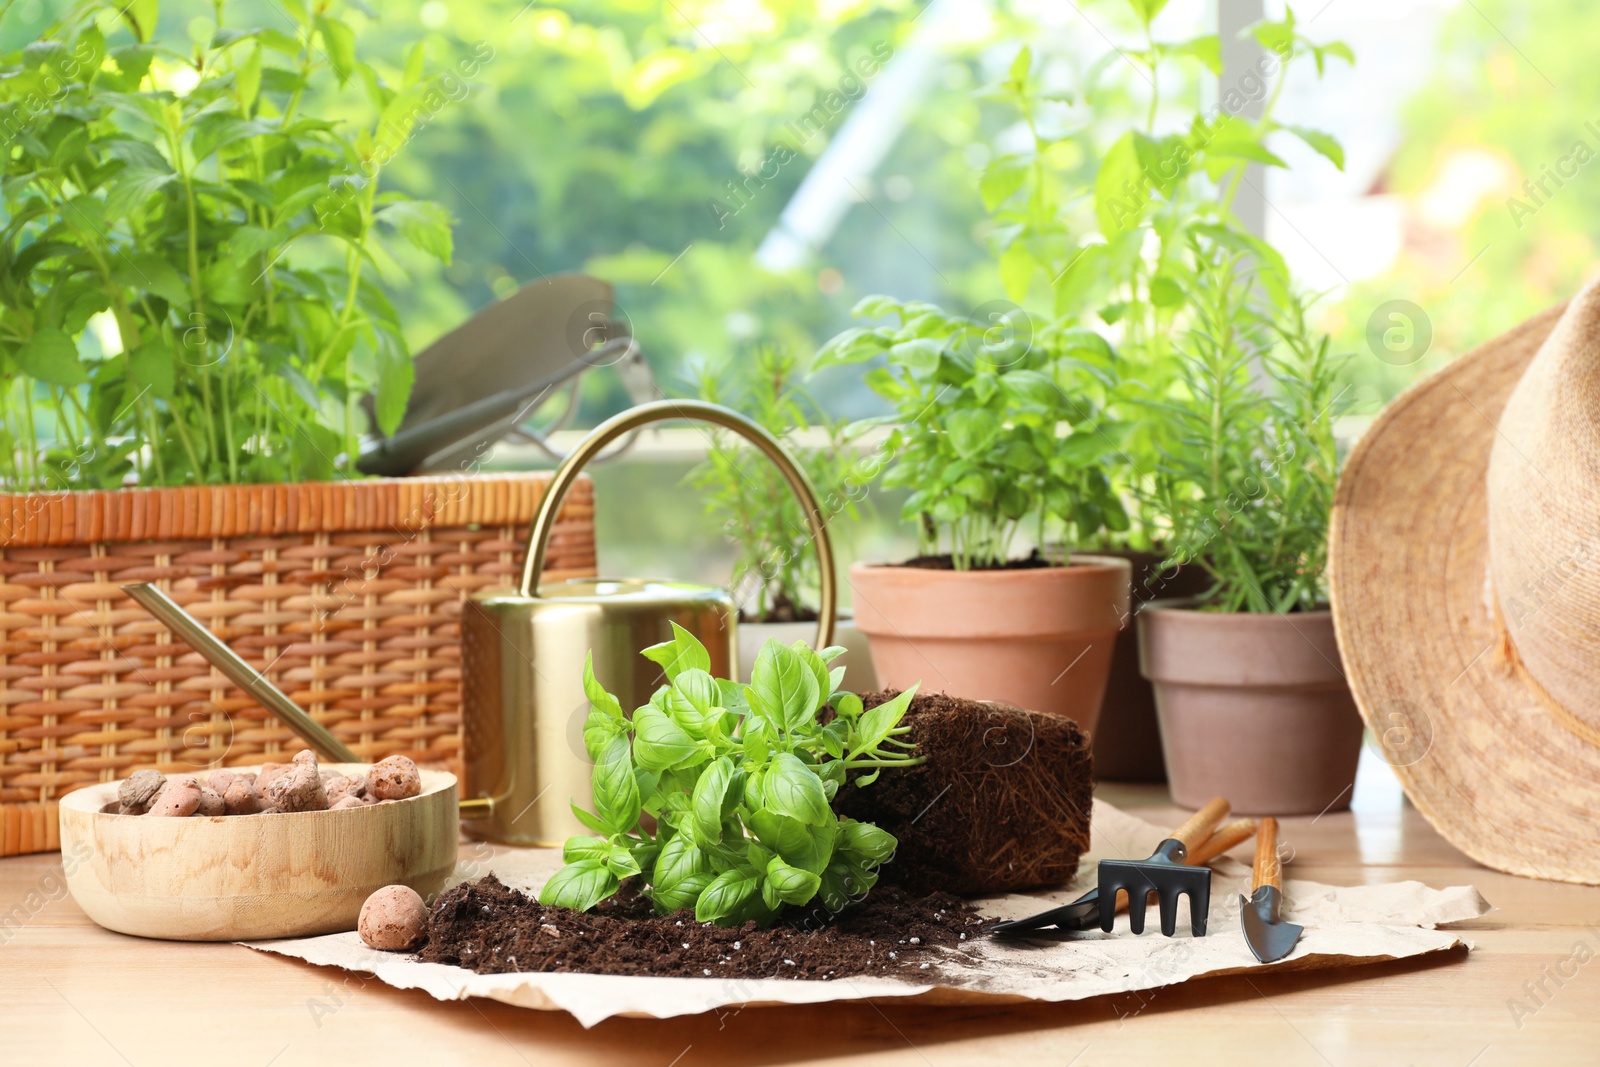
[1138,238,1362,814]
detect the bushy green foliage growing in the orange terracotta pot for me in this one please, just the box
[814,296,1128,569]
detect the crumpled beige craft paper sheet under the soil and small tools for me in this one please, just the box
[250,801,1490,1027]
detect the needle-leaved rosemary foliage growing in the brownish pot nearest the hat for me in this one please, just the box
[1150,238,1347,613]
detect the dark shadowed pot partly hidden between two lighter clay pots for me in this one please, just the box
[1094,552,1211,782]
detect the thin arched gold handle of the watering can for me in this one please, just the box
[520,400,837,648]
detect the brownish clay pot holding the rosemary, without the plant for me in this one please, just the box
[1138,601,1362,816]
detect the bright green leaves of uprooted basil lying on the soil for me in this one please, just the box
[539,624,922,926]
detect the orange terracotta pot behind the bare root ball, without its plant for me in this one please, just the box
[850,555,1130,734]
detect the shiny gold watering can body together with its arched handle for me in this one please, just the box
[461,400,835,845]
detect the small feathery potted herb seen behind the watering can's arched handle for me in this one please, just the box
[688,346,874,691]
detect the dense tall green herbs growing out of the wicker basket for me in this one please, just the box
[0,0,451,490]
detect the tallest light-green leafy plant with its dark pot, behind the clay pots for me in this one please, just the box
[921,8,1350,781]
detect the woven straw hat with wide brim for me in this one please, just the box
[1330,285,1600,883]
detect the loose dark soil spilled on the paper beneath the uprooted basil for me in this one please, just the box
[419,875,986,979]
